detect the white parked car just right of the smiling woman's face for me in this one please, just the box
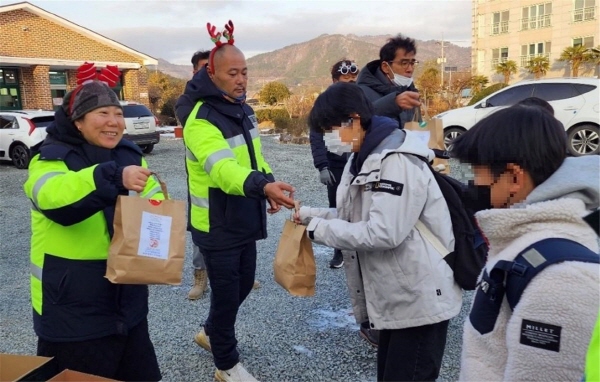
[121,101,160,154]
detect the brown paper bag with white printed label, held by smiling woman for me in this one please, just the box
[105,174,186,285]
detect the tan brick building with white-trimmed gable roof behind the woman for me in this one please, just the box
[0,2,158,110]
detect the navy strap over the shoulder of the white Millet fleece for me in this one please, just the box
[494,238,600,310]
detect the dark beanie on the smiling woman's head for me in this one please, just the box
[63,81,123,121]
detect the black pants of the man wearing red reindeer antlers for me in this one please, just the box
[202,241,256,370]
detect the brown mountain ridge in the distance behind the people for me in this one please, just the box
[158,34,471,92]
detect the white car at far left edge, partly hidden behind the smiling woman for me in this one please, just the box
[0,110,54,169]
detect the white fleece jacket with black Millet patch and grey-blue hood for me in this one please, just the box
[460,155,600,381]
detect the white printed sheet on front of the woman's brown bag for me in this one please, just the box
[138,211,173,260]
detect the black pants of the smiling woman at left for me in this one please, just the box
[37,319,162,381]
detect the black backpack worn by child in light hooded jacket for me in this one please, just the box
[415,156,488,290]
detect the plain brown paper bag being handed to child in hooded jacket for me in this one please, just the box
[273,207,317,297]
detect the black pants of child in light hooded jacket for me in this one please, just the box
[377,321,448,381]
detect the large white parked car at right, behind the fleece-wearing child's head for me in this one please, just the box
[436,78,600,156]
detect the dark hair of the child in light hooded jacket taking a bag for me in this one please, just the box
[308,82,374,133]
